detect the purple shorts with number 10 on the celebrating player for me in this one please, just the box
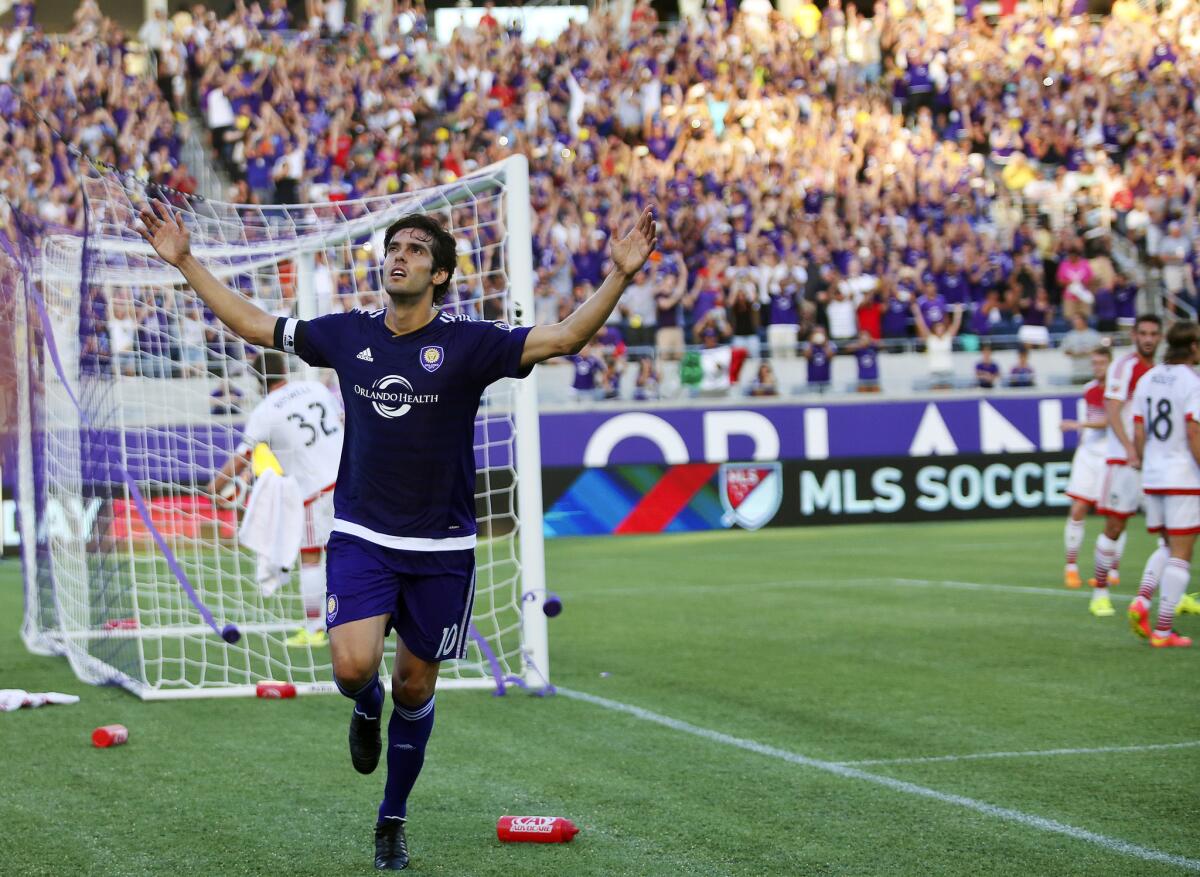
[325,533,475,663]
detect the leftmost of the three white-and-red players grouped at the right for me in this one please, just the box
[1062,347,1112,588]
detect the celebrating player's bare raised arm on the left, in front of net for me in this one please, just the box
[138,202,276,347]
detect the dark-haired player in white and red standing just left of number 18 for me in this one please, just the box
[1088,313,1163,618]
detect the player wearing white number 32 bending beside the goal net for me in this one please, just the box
[212,350,343,645]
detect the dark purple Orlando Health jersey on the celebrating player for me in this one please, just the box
[274,304,529,551]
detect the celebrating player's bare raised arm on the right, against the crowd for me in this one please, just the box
[521,208,658,368]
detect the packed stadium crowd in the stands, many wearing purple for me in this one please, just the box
[0,0,1200,397]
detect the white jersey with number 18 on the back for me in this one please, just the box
[1133,362,1200,493]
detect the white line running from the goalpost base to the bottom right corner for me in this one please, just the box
[558,687,1200,872]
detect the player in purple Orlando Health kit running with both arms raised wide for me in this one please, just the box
[140,203,658,871]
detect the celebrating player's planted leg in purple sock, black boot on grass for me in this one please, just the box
[376,637,440,871]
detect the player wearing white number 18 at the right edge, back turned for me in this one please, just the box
[1128,320,1200,648]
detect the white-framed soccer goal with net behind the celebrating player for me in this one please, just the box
[8,156,550,699]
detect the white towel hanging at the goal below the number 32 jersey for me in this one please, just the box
[238,469,304,596]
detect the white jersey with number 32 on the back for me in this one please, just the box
[238,380,344,499]
